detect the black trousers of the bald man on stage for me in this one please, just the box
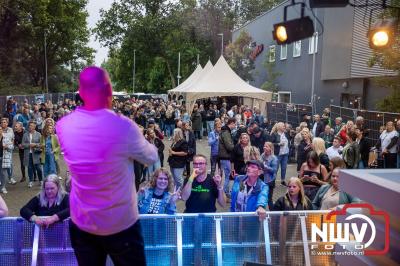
[69,220,146,266]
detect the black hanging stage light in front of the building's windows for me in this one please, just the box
[272,17,314,44]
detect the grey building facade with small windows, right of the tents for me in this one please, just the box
[232,1,394,112]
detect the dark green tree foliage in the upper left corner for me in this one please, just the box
[0,0,94,94]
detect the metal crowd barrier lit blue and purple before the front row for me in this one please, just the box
[0,211,335,266]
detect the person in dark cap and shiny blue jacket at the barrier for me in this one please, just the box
[231,160,269,219]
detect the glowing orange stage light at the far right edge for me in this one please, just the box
[367,19,397,50]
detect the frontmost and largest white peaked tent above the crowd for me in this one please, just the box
[169,56,272,112]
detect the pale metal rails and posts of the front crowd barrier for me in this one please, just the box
[0,210,330,266]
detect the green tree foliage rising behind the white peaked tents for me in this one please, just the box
[95,0,277,92]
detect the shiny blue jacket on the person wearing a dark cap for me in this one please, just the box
[231,175,269,212]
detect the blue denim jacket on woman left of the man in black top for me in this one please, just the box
[138,188,176,214]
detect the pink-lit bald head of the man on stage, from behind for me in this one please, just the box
[79,66,112,109]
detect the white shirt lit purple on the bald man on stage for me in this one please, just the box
[57,108,158,235]
